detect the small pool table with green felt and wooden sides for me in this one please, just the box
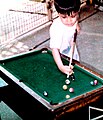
[0,48,103,120]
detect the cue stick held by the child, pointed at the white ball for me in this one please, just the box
[67,29,77,78]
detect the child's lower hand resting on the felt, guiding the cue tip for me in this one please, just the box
[59,65,74,75]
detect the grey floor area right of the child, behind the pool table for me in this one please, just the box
[77,12,103,75]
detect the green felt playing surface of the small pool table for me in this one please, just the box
[2,51,102,103]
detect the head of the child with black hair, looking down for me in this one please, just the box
[54,0,80,26]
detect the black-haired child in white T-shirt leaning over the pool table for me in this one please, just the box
[50,0,80,75]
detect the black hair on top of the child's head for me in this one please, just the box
[54,0,80,15]
